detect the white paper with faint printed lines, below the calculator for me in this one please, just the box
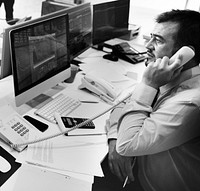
[26,135,108,176]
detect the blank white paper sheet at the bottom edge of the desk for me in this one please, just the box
[13,165,92,191]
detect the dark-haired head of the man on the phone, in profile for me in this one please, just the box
[146,10,200,63]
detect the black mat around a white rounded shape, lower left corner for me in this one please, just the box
[0,146,21,187]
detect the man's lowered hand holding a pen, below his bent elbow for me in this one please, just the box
[108,140,134,181]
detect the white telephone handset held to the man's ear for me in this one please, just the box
[169,46,195,68]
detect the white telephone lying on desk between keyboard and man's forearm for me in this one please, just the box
[79,74,118,102]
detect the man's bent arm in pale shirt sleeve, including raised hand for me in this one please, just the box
[117,58,199,156]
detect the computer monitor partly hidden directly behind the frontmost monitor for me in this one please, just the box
[0,3,92,79]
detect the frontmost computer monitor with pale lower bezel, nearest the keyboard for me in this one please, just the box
[10,12,71,106]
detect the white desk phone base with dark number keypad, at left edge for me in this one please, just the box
[0,106,36,152]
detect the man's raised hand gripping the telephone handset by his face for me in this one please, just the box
[142,56,182,89]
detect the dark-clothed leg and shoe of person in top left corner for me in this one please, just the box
[0,0,19,25]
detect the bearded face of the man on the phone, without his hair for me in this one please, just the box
[146,22,179,64]
